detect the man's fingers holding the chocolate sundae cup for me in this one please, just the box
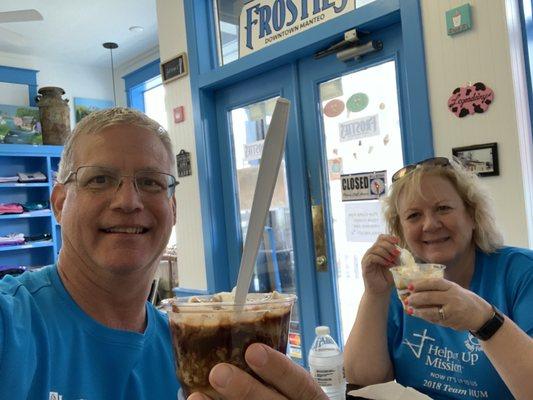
[188,343,328,400]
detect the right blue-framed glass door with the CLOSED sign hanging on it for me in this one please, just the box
[299,22,404,343]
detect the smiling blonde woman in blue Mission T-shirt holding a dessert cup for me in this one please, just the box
[344,157,533,399]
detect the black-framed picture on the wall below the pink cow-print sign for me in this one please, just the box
[452,143,500,176]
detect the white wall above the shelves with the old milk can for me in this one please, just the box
[0,52,113,128]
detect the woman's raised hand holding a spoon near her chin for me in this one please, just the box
[361,235,400,295]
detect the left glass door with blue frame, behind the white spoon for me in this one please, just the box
[216,66,316,364]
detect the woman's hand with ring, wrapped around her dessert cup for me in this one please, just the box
[406,278,492,331]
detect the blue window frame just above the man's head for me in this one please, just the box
[122,59,162,112]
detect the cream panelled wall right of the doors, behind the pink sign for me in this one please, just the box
[421,0,528,247]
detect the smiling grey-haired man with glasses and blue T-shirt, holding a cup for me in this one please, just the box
[0,108,325,400]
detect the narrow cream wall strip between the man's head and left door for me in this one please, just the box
[157,0,207,289]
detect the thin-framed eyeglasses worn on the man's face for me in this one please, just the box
[62,166,178,198]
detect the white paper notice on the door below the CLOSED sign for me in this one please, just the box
[344,201,386,242]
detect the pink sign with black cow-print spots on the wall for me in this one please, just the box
[448,82,494,118]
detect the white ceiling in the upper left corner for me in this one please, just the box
[0,0,158,67]
